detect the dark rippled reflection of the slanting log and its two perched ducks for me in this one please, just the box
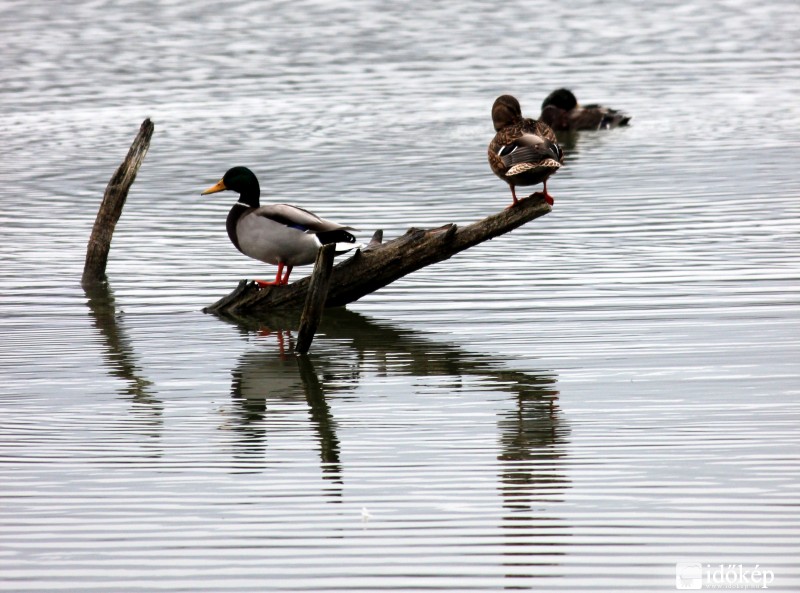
[222,309,569,524]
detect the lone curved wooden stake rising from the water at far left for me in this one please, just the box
[81,118,154,288]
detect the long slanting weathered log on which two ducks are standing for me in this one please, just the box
[204,192,551,317]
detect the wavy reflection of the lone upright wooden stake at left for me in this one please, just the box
[84,284,164,435]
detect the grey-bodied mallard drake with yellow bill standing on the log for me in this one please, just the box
[201,167,356,286]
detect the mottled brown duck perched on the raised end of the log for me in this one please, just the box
[489,95,564,206]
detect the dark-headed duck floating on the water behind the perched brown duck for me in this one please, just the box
[539,89,631,132]
